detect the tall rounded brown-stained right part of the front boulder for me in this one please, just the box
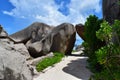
[50,23,76,54]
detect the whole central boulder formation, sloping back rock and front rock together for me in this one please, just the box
[10,22,76,57]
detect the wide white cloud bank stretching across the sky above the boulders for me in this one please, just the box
[3,0,101,25]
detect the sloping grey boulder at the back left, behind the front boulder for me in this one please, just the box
[10,22,51,44]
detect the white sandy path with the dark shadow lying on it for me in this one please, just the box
[34,51,91,80]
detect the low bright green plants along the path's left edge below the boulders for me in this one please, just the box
[36,52,64,72]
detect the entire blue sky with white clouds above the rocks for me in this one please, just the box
[0,0,102,43]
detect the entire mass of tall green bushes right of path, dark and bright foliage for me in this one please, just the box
[82,16,120,80]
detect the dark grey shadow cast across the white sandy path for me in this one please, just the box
[62,57,91,80]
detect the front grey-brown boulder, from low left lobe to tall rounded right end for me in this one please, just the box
[26,23,76,57]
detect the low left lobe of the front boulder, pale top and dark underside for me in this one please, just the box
[26,33,51,58]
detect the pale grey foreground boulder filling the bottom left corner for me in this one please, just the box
[0,47,32,80]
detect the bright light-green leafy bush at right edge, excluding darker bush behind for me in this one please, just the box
[94,20,120,80]
